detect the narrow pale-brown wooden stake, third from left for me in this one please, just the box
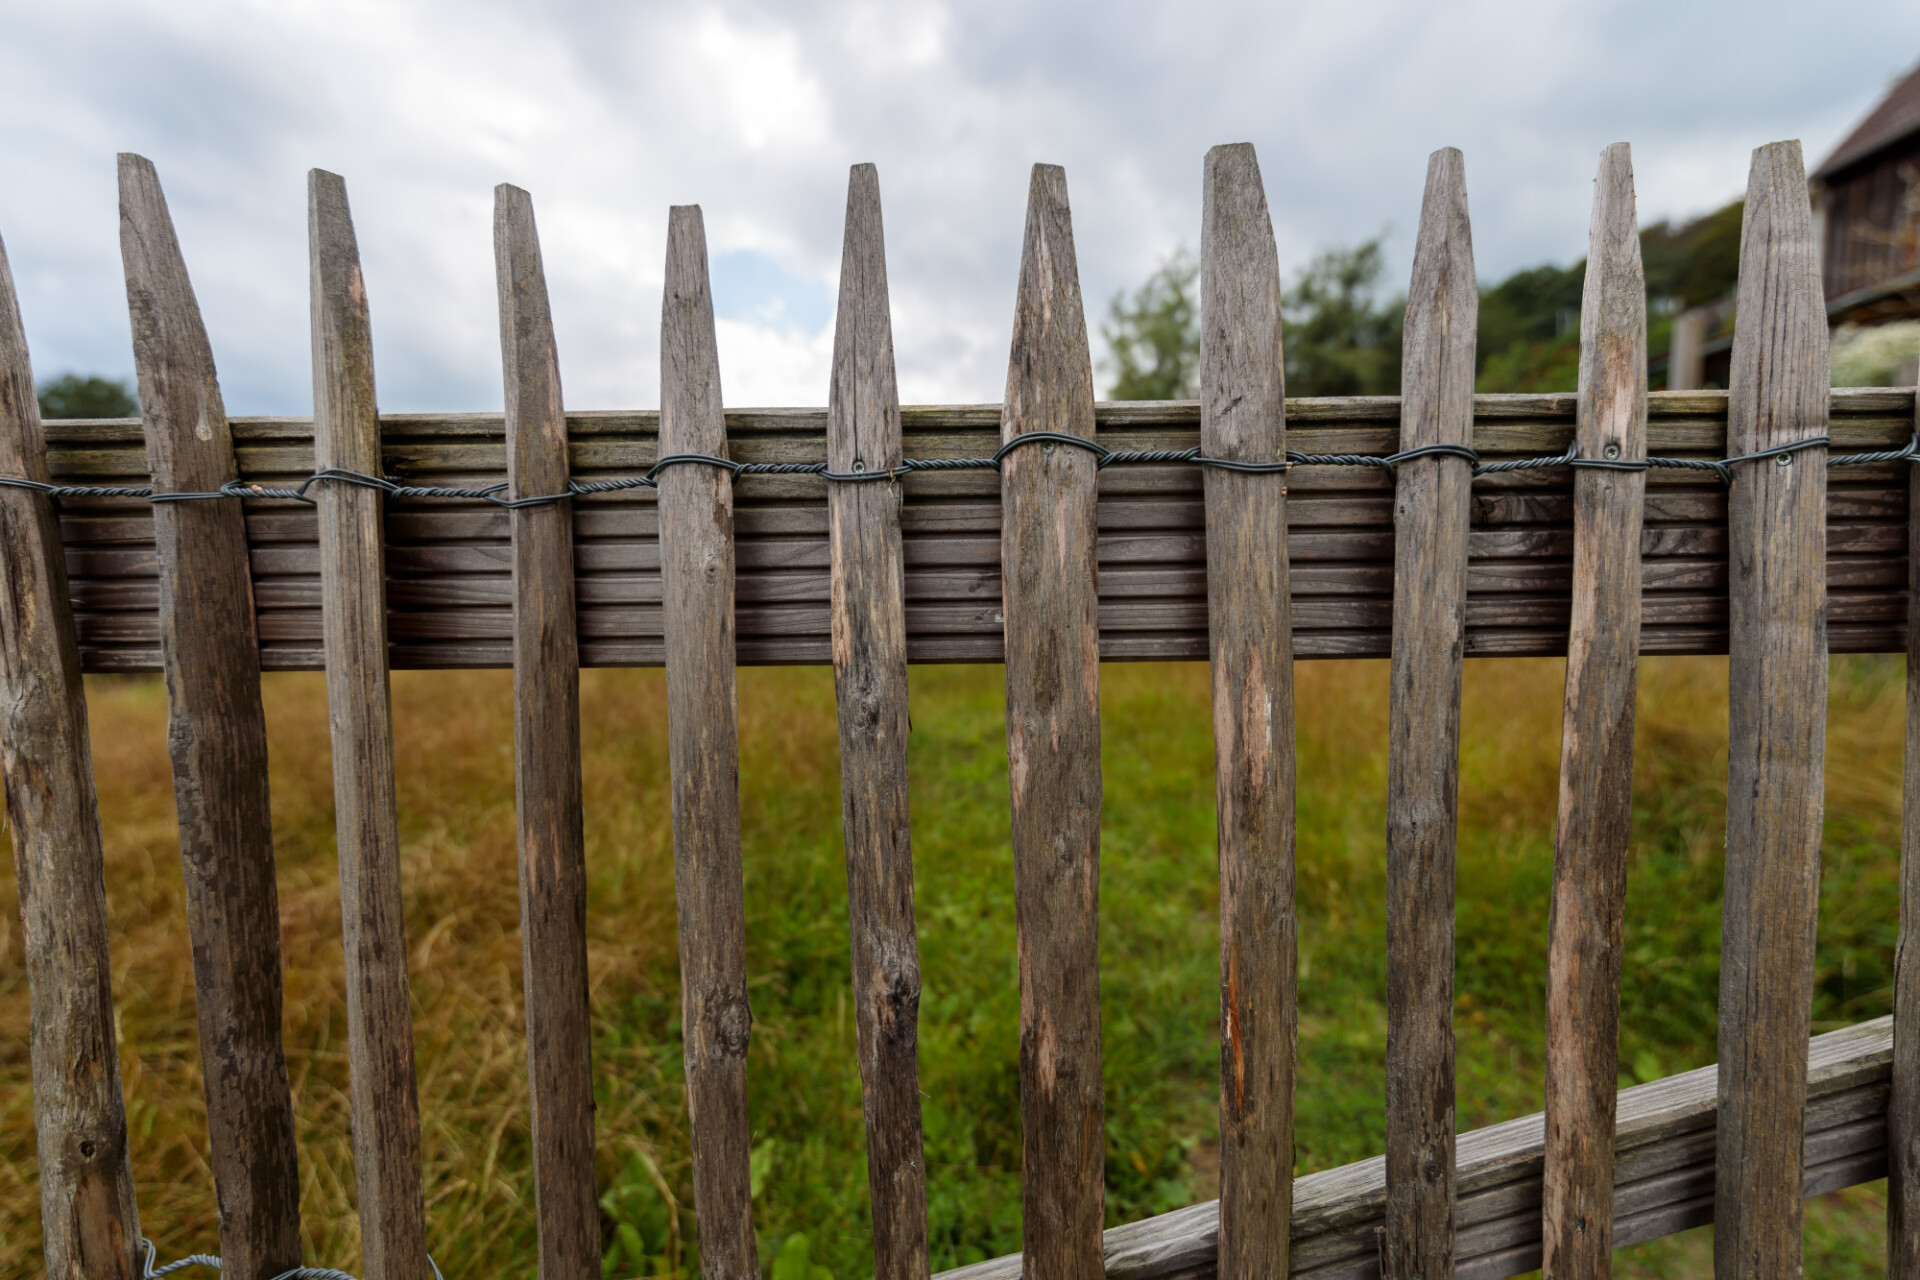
[307,169,430,1280]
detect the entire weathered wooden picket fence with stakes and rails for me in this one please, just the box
[0,144,1920,1280]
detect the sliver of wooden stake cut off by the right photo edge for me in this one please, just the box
[1889,320,1920,1280]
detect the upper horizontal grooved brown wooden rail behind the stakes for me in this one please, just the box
[46,388,1914,672]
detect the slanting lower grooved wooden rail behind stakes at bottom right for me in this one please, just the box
[937,1017,1893,1280]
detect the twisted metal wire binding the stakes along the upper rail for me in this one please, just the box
[0,432,1920,510]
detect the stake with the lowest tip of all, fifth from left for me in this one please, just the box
[660,205,760,1280]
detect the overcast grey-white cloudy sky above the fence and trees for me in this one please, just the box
[0,0,1920,413]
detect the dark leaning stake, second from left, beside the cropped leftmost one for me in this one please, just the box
[119,154,300,1280]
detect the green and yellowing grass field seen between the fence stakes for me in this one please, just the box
[0,658,1903,1280]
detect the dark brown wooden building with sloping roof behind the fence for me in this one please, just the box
[1812,67,1920,324]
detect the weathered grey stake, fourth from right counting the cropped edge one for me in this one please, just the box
[1382,148,1478,1280]
